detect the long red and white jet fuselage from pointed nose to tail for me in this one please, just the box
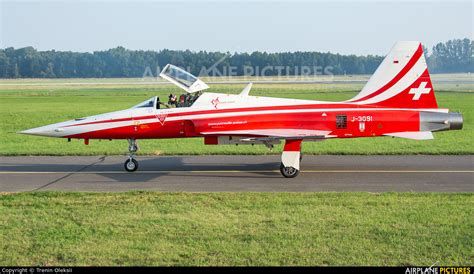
[19,93,460,139]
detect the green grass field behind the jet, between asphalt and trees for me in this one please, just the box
[0,76,474,155]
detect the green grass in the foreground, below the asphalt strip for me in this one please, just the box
[0,192,474,265]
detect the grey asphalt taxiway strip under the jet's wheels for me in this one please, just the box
[0,155,474,192]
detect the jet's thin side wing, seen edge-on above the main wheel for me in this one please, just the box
[201,128,331,141]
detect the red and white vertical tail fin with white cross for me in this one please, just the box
[348,41,438,108]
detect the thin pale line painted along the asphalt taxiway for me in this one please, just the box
[0,170,474,174]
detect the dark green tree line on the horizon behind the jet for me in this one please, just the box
[0,38,474,78]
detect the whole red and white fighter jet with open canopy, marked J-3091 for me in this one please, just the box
[21,42,463,178]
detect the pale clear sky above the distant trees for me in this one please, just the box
[0,0,474,55]
